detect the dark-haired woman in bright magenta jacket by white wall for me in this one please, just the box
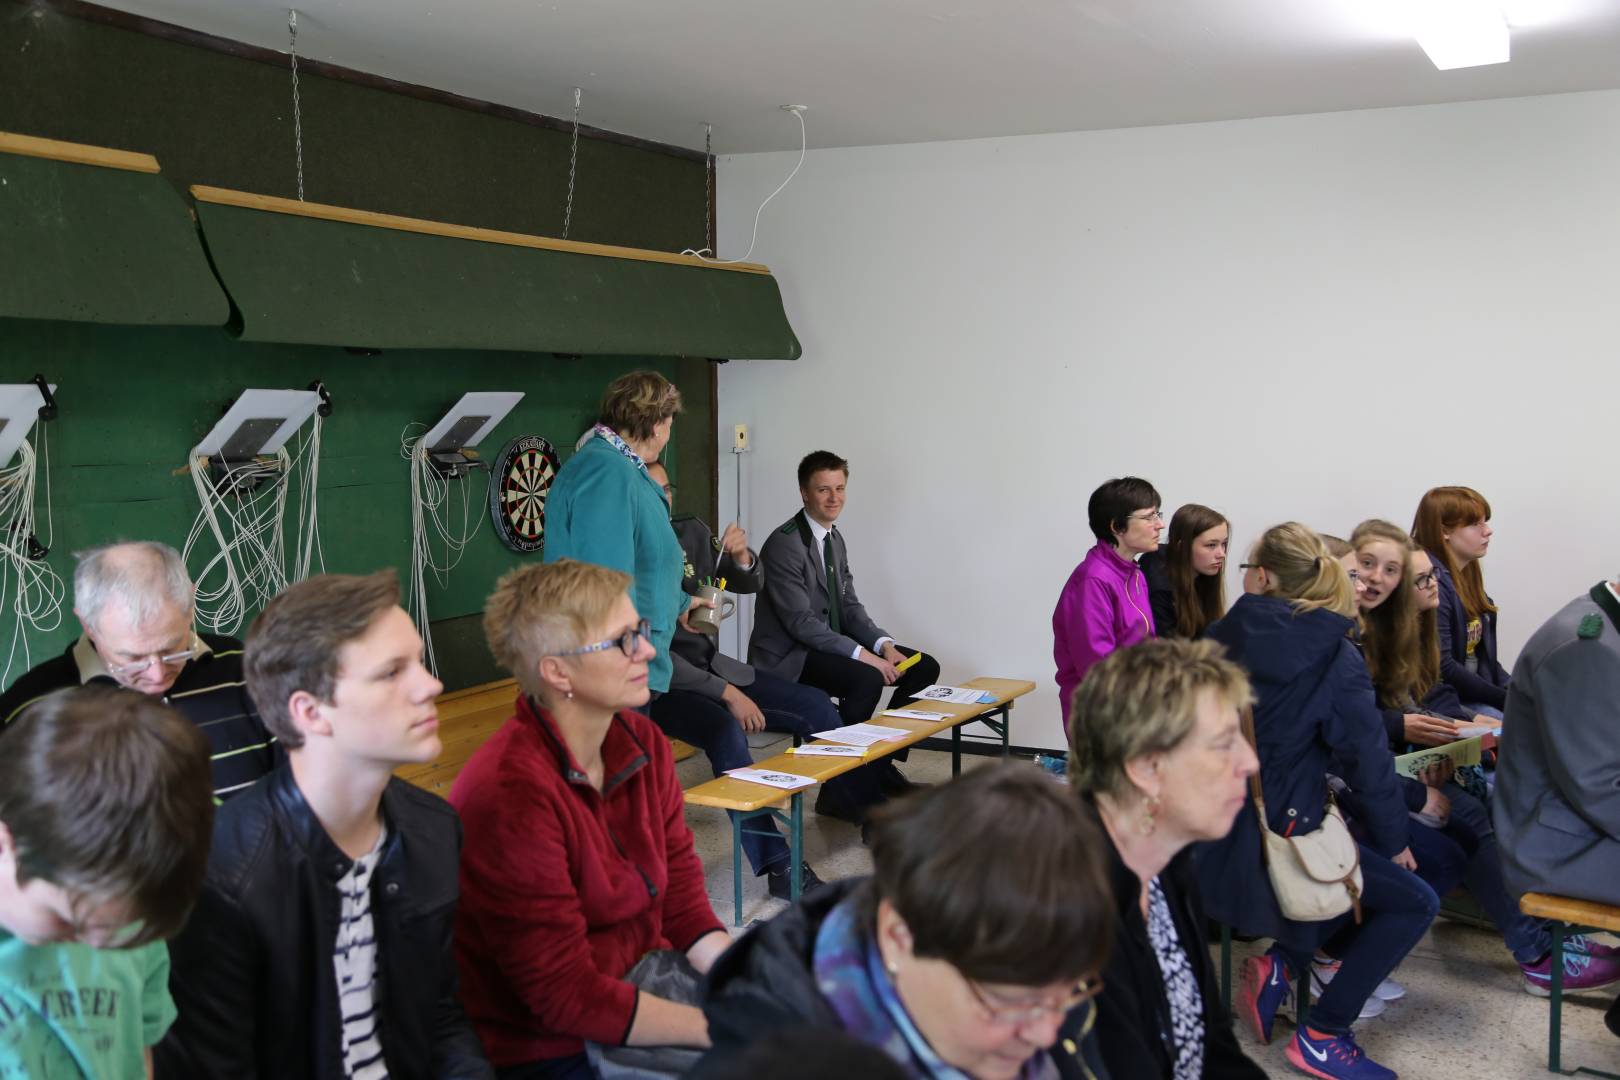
[1051,476,1165,727]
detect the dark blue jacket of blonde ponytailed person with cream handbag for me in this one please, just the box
[1197,594,1408,946]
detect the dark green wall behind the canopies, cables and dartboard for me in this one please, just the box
[0,0,714,688]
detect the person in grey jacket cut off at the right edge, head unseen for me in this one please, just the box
[1492,581,1620,1035]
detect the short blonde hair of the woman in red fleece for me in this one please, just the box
[484,559,630,696]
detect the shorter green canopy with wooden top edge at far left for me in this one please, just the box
[0,133,230,325]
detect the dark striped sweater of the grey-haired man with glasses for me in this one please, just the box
[0,635,282,800]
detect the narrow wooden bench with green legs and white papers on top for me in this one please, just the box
[685,678,1035,926]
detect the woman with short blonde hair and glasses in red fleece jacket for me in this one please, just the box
[450,559,731,1080]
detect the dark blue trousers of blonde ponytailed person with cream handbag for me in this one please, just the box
[1288,845,1440,1035]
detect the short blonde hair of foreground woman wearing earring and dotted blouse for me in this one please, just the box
[1069,638,1254,798]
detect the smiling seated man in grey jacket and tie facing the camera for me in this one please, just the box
[748,450,940,823]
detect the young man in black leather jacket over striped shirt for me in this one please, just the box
[157,570,494,1080]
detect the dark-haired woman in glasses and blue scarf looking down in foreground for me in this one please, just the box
[703,764,1114,1080]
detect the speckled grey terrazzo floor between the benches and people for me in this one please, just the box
[677,735,1620,1080]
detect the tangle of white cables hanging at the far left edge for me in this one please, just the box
[0,437,66,683]
